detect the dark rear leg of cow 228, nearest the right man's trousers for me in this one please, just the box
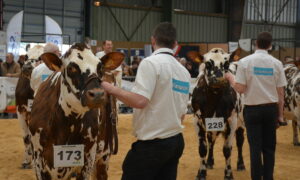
[235,127,246,171]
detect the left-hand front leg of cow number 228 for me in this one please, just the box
[195,114,207,180]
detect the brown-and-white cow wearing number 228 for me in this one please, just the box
[192,48,245,180]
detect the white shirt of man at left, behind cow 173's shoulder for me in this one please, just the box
[30,63,53,94]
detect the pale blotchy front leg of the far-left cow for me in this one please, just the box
[17,112,32,169]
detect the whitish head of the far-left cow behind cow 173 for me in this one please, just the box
[22,45,44,78]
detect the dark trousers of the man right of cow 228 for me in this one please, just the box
[244,104,278,180]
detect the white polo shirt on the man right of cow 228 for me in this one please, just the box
[236,50,287,105]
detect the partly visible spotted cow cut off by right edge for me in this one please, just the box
[284,64,300,146]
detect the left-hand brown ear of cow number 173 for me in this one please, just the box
[40,53,62,71]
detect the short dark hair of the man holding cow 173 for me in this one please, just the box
[152,22,177,49]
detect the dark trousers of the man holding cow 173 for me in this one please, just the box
[122,133,184,180]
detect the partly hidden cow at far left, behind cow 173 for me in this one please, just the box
[15,45,44,169]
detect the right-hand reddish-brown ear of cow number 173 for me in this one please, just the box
[100,52,125,70]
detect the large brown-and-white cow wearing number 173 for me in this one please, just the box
[29,43,124,180]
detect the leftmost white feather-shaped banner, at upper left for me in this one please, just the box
[6,11,23,59]
